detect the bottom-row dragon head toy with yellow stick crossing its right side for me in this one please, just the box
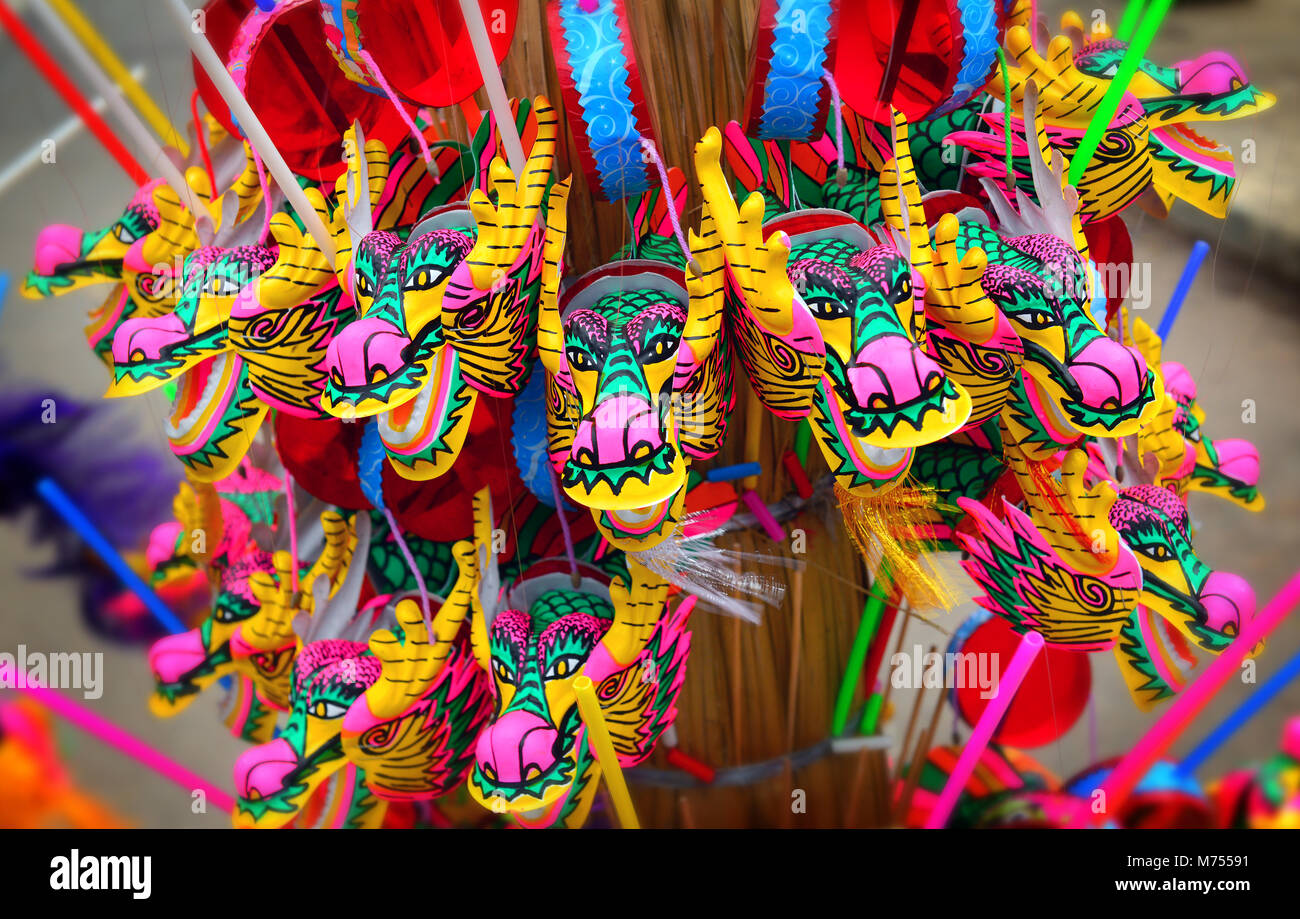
[469,559,694,827]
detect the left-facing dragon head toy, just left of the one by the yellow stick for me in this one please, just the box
[235,515,488,827]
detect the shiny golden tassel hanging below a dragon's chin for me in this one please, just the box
[835,480,954,611]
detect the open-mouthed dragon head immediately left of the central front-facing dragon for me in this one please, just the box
[321,97,558,480]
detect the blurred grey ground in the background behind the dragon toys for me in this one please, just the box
[0,0,1300,827]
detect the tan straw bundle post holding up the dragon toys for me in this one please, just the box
[462,0,888,828]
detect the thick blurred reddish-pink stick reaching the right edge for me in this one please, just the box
[1075,571,1300,825]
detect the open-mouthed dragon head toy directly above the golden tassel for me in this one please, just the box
[696,116,971,495]
